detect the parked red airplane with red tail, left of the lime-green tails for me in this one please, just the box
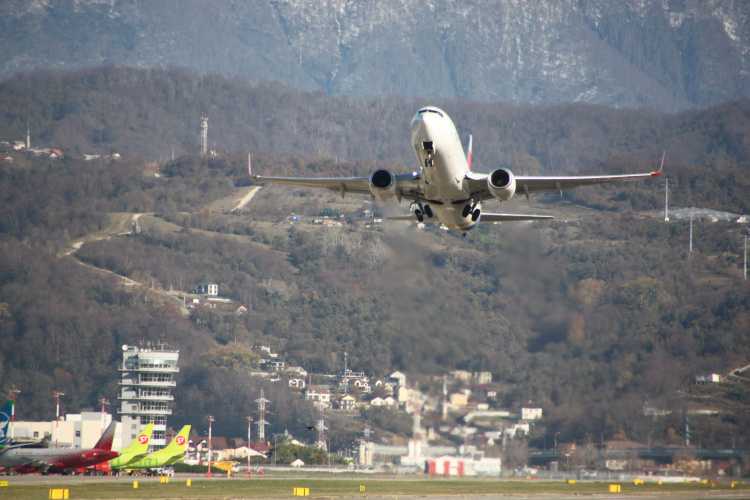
[0,422,118,474]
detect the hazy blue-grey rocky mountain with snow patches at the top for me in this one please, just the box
[0,0,750,111]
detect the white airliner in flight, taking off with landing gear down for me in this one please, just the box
[248,106,664,236]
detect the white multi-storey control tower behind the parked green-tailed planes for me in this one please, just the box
[118,340,180,451]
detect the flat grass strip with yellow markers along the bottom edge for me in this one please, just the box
[0,477,750,500]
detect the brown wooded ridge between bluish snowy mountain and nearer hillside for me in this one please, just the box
[0,66,750,174]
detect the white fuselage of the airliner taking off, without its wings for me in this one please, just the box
[411,107,479,231]
